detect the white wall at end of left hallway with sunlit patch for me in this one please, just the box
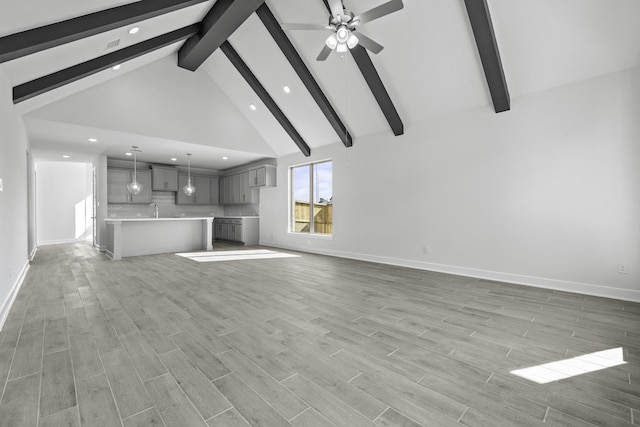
[36,162,93,245]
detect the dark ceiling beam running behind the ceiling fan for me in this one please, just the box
[323,0,404,136]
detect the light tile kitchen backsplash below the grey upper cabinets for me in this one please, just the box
[107,191,228,218]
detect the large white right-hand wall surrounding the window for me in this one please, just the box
[260,68,640,301]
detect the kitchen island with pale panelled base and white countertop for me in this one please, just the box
[105,217,213,260]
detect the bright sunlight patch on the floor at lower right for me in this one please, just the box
[511,347,627,384]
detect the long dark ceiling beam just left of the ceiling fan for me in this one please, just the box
[256,3,353,147]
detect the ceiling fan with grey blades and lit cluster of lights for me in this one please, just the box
[282,0,404,61]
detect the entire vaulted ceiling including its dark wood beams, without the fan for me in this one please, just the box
[0,0,640,169]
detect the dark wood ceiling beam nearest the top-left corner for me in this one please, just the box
[0,0,207,63]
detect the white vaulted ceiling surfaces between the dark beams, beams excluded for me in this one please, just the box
[0,0,640,169]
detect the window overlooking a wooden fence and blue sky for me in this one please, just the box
[290,160,333,235]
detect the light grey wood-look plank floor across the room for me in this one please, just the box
[0,244,640,427]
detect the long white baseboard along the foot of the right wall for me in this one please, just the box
[260,241,640,302]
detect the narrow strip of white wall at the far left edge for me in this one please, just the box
[0,66,29,327]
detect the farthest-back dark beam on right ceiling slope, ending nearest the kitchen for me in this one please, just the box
[220,41,311,157]
